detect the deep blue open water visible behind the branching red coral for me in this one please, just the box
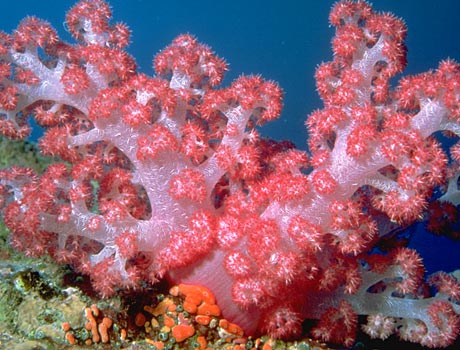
[0,0,460,288]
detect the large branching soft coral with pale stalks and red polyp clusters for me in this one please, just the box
[0,0,460,347]
